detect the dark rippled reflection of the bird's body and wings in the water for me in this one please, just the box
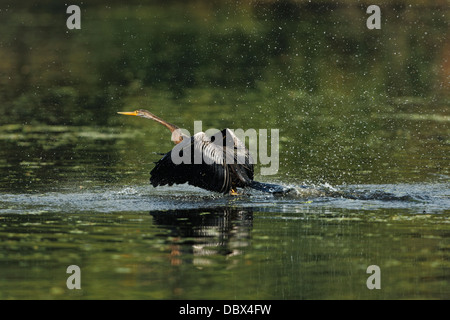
[150,207,253,266]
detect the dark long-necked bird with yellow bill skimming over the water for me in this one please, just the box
[118,109,290,194]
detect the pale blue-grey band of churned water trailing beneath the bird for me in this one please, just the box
[0,184,450,215]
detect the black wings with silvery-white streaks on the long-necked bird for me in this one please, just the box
[150,129,253,193]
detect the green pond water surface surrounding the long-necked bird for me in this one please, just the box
[0,1,450,300]
